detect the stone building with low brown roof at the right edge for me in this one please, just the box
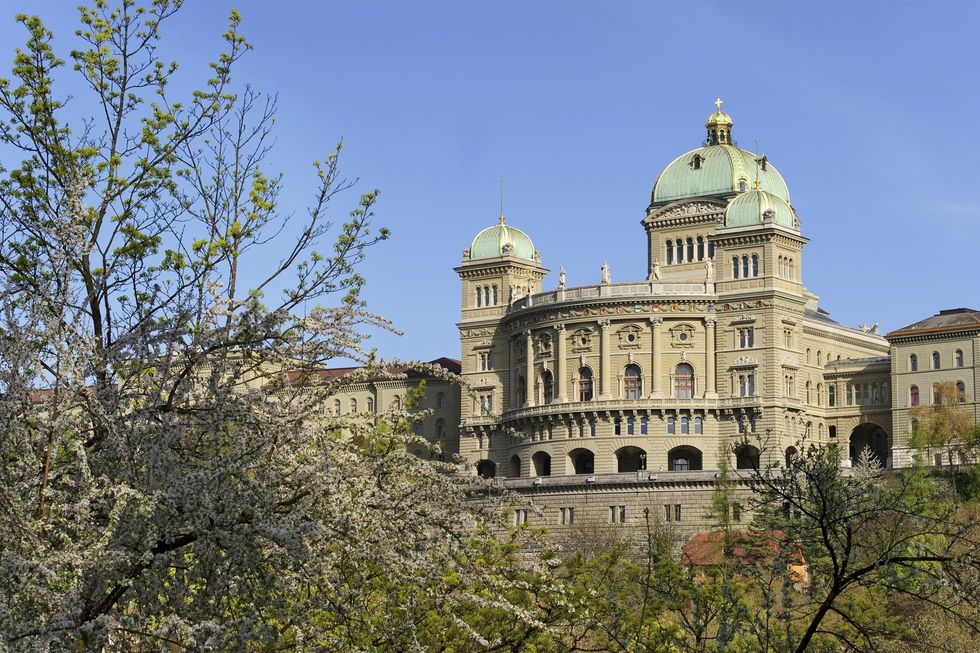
[885,308,980,465]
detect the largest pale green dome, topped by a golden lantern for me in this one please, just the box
[652,145,789,203]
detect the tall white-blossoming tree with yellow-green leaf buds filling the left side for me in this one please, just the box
[0,0,576,650]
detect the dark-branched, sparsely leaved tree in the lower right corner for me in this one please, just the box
[753,446,980,651]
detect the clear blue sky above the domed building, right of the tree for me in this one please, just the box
[0,0,980,359]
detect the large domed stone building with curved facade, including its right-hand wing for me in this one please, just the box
[440,101,980,528]
